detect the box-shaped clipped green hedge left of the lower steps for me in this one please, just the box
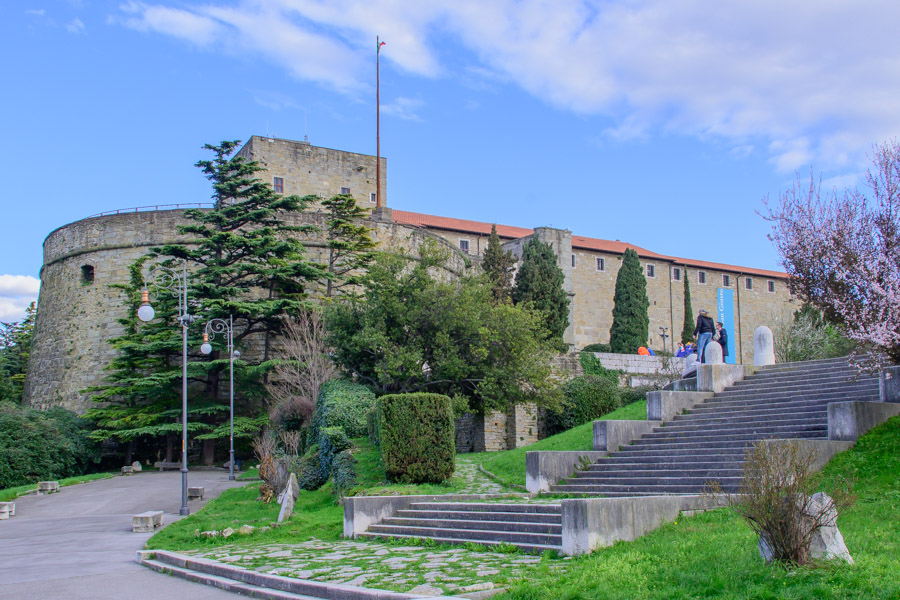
[378,393,456,483]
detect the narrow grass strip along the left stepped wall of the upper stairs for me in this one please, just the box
[466,400,647,486]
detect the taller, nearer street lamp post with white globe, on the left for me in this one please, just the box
[138,261,194,515]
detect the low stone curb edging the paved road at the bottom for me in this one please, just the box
[135,550,472,600]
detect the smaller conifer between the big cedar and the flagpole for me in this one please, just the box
[322,194,375,298]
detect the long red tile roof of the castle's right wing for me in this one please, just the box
[393,210,787,279]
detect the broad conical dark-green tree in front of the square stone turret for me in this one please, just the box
[513,237,569,346]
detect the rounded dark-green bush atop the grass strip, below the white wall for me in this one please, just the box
[547,375,620,435]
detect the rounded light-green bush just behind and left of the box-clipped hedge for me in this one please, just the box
[310,379,375,443]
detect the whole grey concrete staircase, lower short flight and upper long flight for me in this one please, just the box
[354,359,879,552]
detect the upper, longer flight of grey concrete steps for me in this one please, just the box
[550,359,878,498]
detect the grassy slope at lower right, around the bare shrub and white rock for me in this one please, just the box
[497,417,900,600]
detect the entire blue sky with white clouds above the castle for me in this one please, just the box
[0,0,900,321]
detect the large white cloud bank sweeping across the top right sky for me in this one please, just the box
[114,0,900,171]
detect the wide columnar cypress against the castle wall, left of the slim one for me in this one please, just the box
[609,248,650,354]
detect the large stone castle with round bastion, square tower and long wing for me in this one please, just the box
[25,136,793,448]
